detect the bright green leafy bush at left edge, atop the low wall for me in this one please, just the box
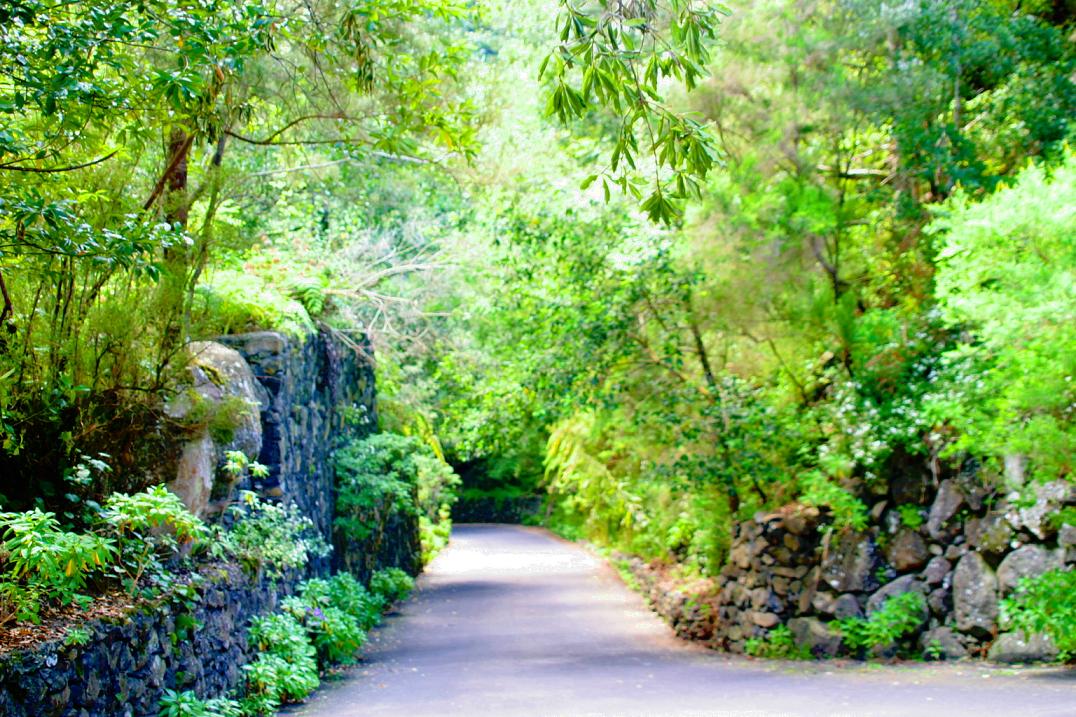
[0,508,116,624]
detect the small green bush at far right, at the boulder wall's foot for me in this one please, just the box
[1001,570,1076,662]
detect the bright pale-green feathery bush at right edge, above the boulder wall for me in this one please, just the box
[930,153,1076,480]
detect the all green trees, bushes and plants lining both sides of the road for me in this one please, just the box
[0,0,1076,689]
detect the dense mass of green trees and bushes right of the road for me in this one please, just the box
[395,0,1076,574]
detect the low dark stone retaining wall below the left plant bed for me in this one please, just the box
[0,567,301,717]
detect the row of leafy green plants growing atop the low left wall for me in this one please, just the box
[0,486,329,624]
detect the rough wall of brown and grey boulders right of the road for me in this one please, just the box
[631,462,1076,662]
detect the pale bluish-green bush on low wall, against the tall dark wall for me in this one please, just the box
[213,491,330,578]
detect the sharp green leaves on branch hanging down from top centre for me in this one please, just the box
[539,0,727,223]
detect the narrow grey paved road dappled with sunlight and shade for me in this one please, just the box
[291,518,1076,717]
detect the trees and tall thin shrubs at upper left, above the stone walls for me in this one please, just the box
[0,0,473,503]
